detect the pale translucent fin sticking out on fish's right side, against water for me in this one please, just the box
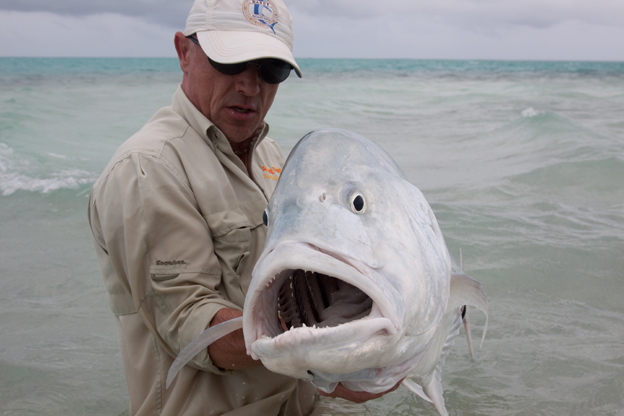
[447,269,488,355]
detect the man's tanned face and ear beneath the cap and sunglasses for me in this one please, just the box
[176,35,278,143]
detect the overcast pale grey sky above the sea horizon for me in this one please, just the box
[0,0,624,61]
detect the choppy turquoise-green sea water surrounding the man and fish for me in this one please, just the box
[0,58,624,416]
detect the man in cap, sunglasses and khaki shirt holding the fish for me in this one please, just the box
[89,0,394,416]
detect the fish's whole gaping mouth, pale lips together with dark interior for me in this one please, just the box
[243,240,402,352]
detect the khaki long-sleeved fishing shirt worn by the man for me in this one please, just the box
[89,87,315,416]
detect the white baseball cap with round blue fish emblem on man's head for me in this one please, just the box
[184,0,302,78]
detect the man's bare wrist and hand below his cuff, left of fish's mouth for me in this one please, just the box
[208,308,262,370]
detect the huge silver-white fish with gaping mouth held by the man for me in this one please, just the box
[168,129,487,415]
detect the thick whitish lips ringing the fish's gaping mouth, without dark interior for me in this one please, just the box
[243,240,403,357]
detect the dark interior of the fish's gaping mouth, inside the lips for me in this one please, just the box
[273,269,373,336]
